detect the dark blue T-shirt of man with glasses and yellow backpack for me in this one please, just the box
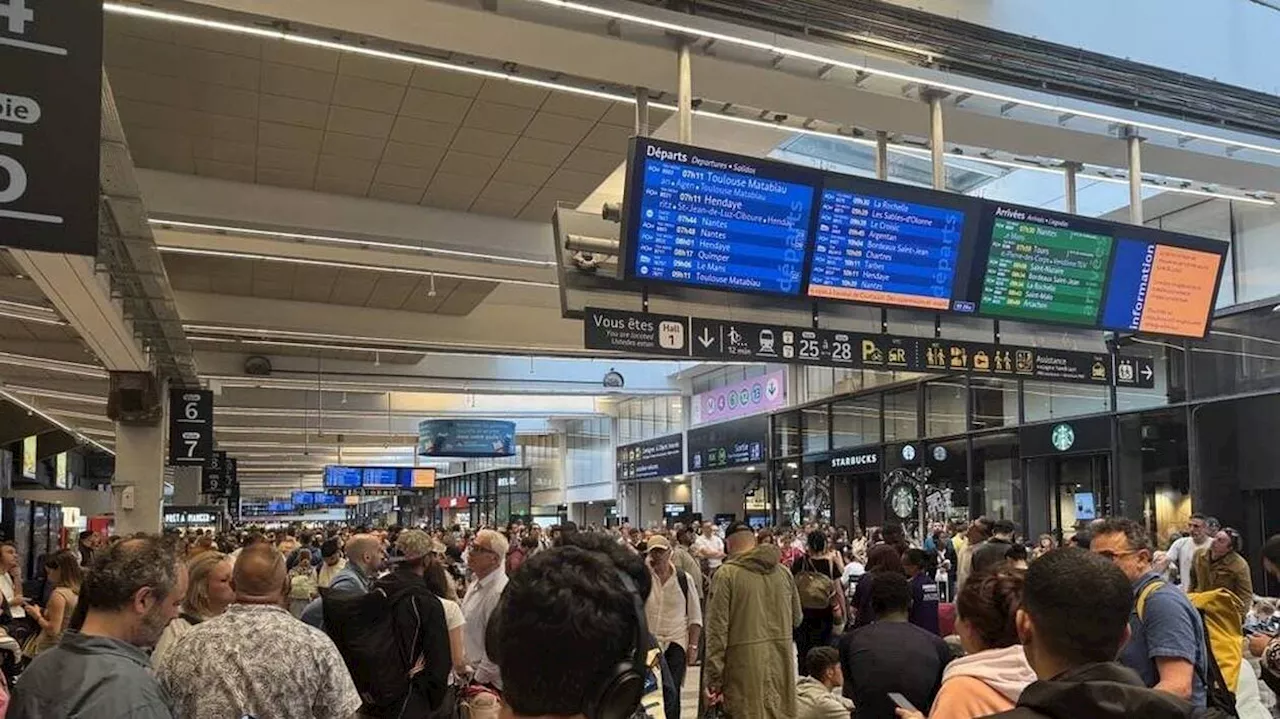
[1119,572,1208,706]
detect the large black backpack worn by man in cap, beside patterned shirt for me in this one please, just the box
[323,586,424,715]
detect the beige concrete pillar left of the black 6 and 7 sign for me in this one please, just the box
[111,420,167,536]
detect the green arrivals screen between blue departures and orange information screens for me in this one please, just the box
[979,212,1112,325]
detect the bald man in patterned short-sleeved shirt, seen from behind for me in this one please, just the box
[156,544,361,719]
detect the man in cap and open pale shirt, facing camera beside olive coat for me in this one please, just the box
[644,535,703,692]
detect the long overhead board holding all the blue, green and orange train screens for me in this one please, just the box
[622,138,1228,340]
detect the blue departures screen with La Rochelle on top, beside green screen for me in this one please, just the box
[809,188,965,310]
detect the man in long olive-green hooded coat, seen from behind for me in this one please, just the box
[703,522,804,716]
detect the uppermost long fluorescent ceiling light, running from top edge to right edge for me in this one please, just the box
[519,0,1280,155]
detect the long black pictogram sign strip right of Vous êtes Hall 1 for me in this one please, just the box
[690,317,1156,389]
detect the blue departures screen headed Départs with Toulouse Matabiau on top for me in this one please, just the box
[628,139,817,296]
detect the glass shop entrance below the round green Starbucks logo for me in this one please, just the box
[1025,454,1111,541]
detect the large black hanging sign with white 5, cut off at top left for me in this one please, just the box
[0,0,102,255]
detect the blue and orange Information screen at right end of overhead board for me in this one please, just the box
[1102,237,1222,336]
